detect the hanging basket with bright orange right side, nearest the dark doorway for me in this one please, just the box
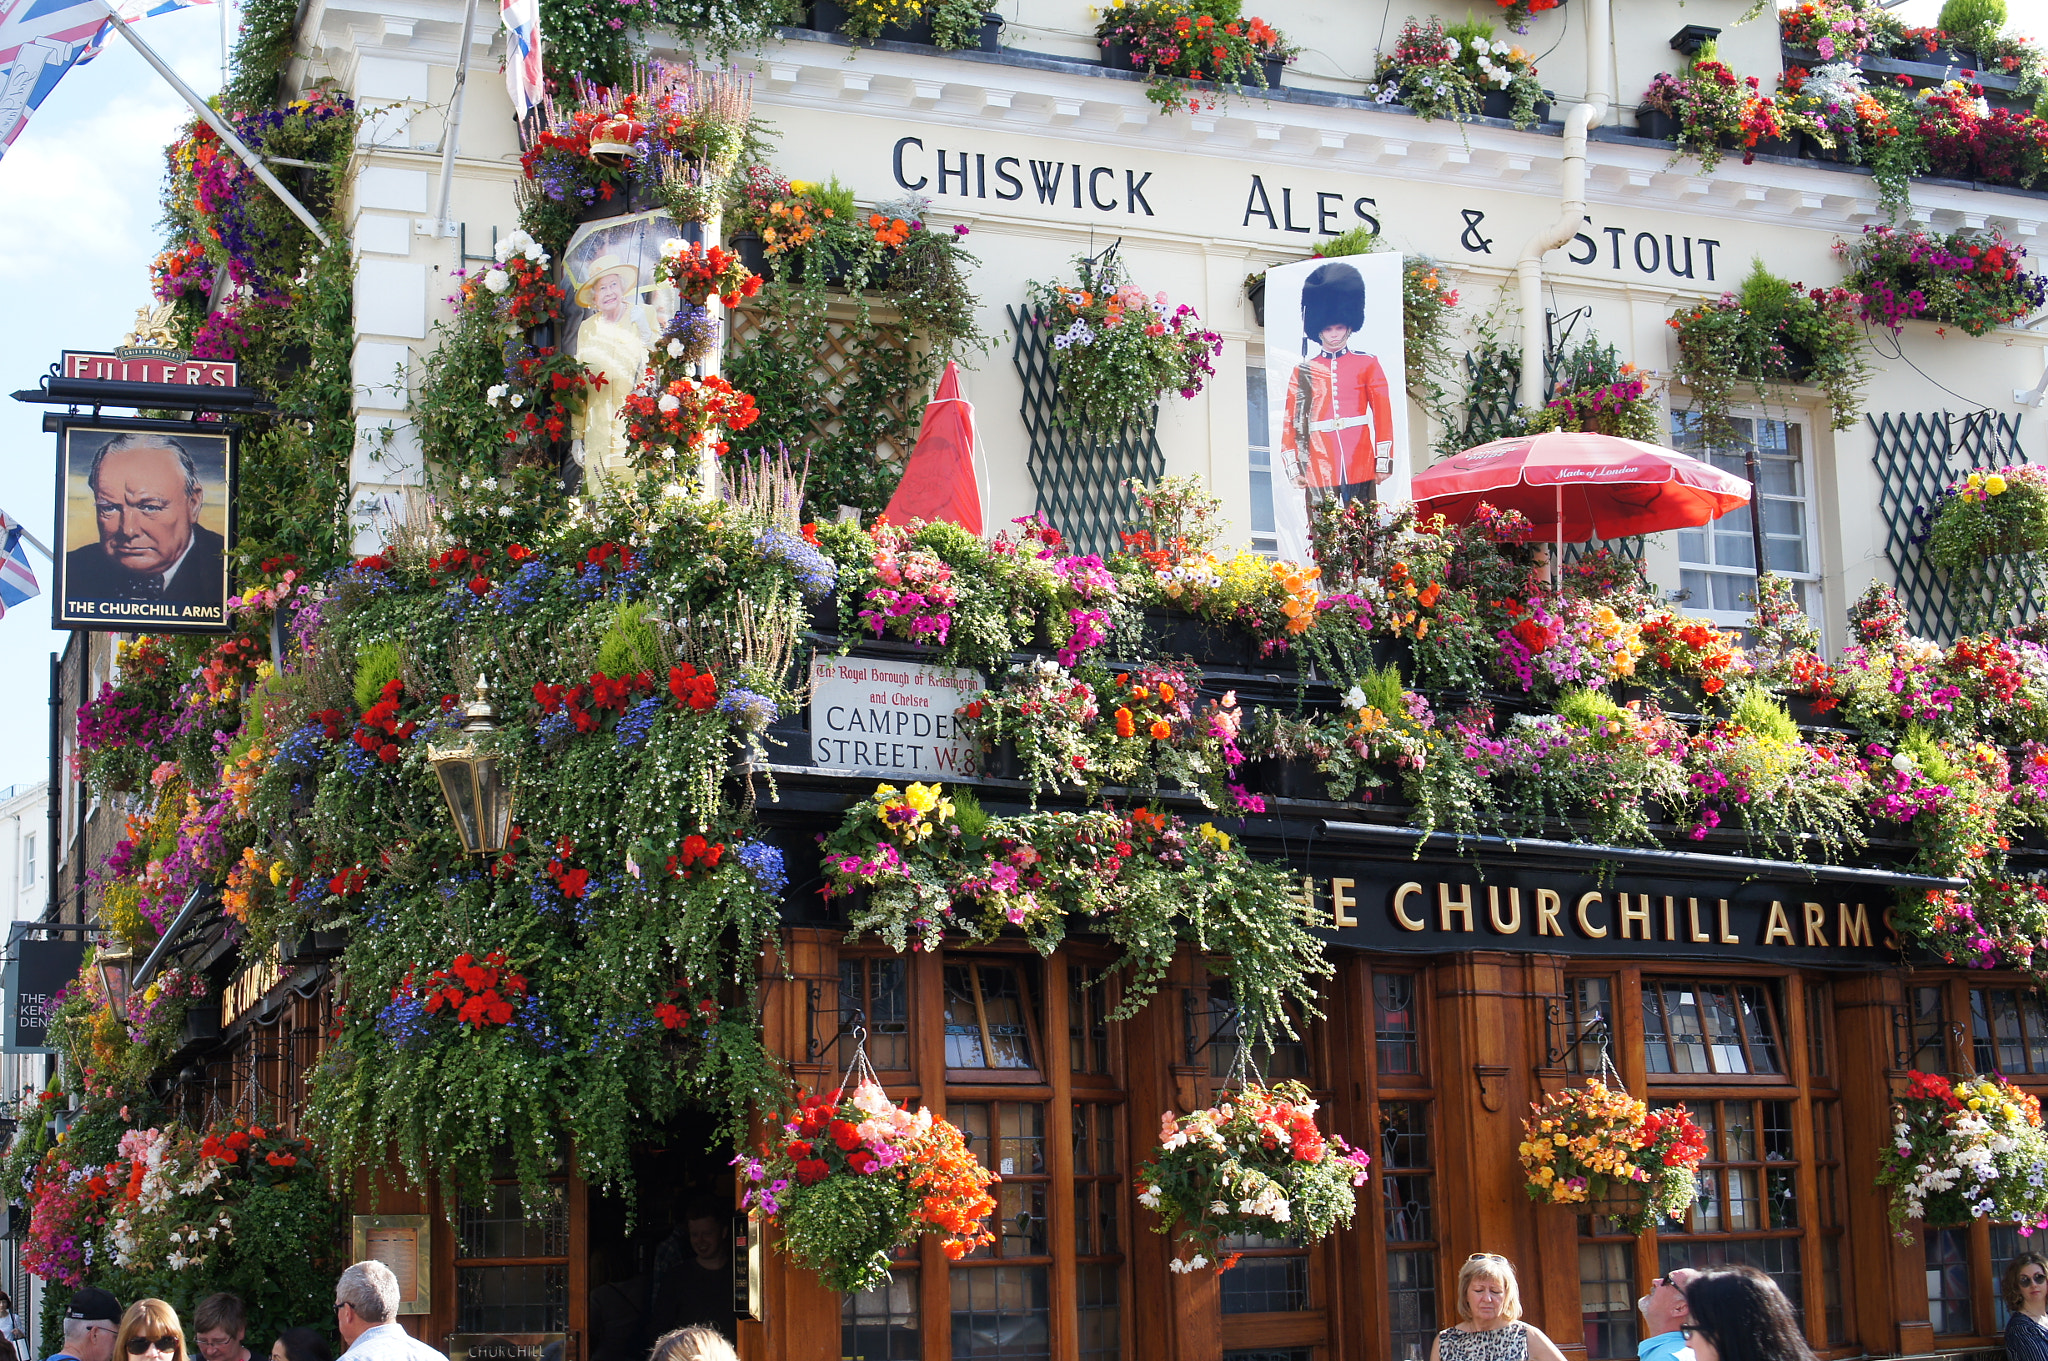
[733,1062,995,1296]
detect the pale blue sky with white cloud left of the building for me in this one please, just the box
[0,0,2007,786]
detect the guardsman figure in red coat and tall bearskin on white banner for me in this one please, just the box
[1280,260,1395,520]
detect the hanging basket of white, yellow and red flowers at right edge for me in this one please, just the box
[1878,1072,2048,1242]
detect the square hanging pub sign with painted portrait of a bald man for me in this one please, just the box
[51,418,236,632]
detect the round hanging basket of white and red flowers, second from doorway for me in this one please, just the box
[1139,1083,1372,1273]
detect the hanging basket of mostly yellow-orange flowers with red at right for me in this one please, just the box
[1520,1081,1706,1236]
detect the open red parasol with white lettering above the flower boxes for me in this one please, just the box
[1411,430,1749,542]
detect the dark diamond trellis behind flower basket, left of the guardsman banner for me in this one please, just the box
[1006,307,1165,557]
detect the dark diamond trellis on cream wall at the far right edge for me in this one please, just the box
[1864,411,2048,643]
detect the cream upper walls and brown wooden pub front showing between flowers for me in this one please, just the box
[48,0,2048,1361]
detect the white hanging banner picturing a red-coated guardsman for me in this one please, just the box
[1266,252,1411,563]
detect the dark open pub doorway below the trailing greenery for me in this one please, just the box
[586,1109,745,1361]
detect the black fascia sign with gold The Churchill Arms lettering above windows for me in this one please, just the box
[1303,860,1898,968]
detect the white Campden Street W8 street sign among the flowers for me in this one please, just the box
[811,655,983,780]
